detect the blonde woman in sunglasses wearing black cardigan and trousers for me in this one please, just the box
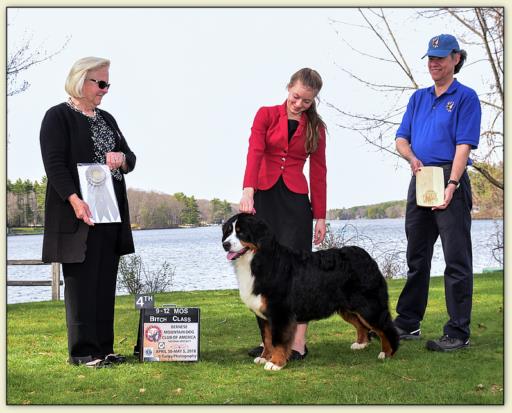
[40,57,135,368]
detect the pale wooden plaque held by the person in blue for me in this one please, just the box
[416,166,444,207]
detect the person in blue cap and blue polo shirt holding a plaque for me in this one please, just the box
[395,34,481,351]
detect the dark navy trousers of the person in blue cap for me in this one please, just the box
[395,168,473,339]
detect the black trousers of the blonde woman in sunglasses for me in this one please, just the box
[62,224,120,363]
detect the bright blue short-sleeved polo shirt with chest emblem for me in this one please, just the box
[396,79,482,166]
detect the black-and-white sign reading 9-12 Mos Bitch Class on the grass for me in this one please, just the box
[140,307,200,361]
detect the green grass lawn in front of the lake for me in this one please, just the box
[6,272,504,405]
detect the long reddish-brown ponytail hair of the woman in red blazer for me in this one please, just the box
[288,67,327,153]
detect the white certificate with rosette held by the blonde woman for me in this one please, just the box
[77,163,121,224]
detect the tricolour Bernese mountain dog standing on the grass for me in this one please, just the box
[222,213,399,370]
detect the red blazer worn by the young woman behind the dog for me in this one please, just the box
[243,102,327,219]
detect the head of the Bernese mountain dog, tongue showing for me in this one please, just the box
[222,214,269,261]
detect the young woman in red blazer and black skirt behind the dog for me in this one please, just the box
[240,68,327,360]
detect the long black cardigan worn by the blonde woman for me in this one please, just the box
[39,103,136,263]
